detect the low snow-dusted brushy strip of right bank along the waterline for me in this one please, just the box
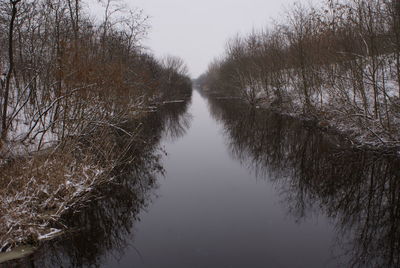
[201,87,400,155]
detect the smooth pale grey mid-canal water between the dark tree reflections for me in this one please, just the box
[108,92,342,267]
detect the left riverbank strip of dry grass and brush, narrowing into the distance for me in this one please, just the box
[0,89,191,260]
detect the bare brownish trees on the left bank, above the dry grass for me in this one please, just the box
[0,0,191,152]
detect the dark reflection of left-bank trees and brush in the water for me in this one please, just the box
[6,95,191,267]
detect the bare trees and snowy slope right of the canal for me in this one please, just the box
[199,0,400,146]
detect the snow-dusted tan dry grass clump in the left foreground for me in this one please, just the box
[0,123,133,252]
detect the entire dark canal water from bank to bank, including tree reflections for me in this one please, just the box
[4,91,400,267]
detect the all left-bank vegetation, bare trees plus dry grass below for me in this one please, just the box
[0,0,191,252]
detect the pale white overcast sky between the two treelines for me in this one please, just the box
[90,0,304,78]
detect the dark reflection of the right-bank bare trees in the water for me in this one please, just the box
[209,93,400,267]
